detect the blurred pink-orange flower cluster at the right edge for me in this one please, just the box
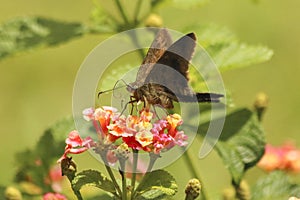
[258,143,300,173]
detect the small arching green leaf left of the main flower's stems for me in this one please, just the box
[72,170,116,194]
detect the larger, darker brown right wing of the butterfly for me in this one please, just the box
[145,33,196,98]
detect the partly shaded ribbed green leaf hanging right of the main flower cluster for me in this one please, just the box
[199,109,265,185]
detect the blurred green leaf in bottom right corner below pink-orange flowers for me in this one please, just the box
[251,171,300,200]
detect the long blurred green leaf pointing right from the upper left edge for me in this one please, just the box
[0,16,86,59]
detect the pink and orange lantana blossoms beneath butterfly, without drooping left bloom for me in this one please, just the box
[83,106,187,154]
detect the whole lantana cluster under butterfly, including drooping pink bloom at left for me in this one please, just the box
[59,106,188,163]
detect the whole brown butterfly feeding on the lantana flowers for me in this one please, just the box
[127,29,223,109]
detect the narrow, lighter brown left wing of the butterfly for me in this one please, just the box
[132,29,172,87]
